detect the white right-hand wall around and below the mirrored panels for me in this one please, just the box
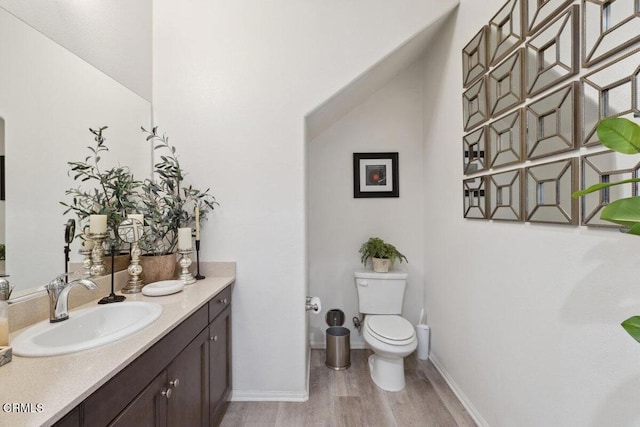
[424,0,640,427]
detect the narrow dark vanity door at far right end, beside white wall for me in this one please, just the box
[209,306,231,425]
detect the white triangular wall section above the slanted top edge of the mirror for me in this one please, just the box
[0,0,152,101]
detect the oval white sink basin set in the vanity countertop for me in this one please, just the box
[11,301,162,357]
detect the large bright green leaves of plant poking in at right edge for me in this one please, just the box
[573,117,640,342]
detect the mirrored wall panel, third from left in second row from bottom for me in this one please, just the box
[526,82,579,159]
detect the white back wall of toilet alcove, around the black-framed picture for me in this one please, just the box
[307,61,424,348]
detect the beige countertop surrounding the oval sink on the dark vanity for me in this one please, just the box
[0,276,235,427]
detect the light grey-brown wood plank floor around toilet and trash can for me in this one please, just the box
[221,350,476,427]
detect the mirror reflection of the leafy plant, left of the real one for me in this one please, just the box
[60,126,142,241]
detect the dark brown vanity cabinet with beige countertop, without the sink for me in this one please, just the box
[0,268,235,427]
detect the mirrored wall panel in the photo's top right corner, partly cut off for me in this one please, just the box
[584,0,640,67]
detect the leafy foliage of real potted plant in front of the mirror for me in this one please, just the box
[139,127,218,255]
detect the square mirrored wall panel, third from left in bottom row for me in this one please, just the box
[525,158,578,224]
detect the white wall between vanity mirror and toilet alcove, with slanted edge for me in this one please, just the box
[153,0,457,399]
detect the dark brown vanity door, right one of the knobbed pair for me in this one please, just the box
[167,329,209,427]
